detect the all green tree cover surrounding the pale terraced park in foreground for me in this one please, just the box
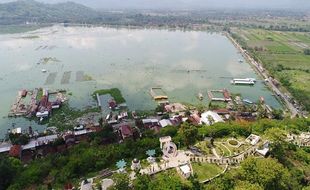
[0,119,310,189]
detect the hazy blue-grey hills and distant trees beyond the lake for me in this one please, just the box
[0,0,310,32]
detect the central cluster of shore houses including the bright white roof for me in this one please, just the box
[105,103,226,141]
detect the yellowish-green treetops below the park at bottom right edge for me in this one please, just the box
[207,157,300,190]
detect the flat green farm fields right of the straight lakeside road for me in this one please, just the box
[232,29,310,111]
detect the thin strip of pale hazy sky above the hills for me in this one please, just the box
[0,0,310,12]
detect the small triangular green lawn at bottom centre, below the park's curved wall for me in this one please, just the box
[192,163,223,181]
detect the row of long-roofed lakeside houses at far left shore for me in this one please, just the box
[0,118,102,163]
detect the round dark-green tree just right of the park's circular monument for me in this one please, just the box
[179,123,198,146]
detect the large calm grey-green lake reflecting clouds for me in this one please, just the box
[0,25,281,138]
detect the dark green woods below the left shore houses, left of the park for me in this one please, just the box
[0,124,160,189]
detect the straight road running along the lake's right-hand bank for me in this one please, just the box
[227,34,298,118]
